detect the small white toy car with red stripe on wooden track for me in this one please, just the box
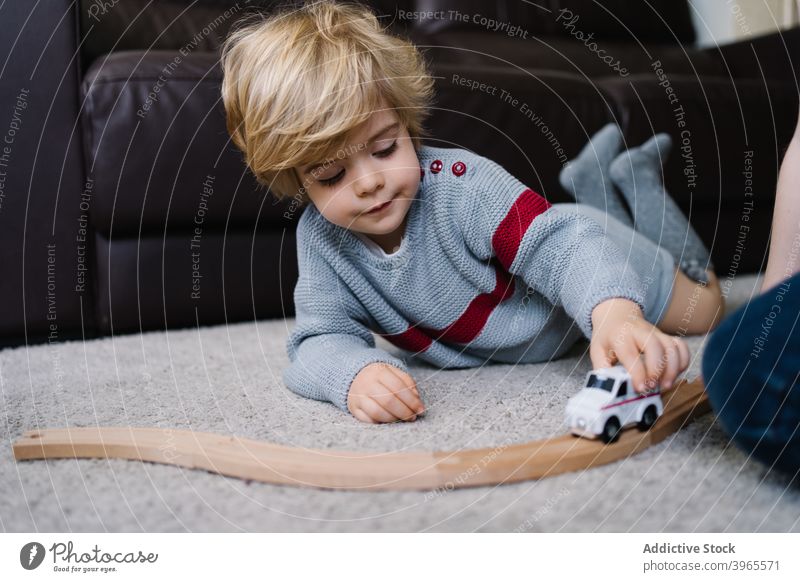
[567,366,664,443]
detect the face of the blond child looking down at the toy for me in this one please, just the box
[297,109,420,250]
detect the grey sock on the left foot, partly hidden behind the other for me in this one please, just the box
[558,123,632,226]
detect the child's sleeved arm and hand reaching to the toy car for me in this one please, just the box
[457,158,689,391]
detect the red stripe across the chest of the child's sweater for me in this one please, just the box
[383,261,514,352]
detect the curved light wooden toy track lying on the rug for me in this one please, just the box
[13,380,710,490]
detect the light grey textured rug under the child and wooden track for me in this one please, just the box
[0,277,800,532]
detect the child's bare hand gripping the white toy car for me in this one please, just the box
[589,299,690,392]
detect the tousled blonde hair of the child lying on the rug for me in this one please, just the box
[221,0,433,204]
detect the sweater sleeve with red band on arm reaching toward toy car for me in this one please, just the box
[457,156,644,338]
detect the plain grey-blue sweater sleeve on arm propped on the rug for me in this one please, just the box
[283,212,408,413]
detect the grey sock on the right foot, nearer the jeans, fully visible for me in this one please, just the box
[609,133,713,283]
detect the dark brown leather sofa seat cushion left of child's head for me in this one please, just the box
[81,51,290,235]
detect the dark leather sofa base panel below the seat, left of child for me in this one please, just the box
[94,230,297,334]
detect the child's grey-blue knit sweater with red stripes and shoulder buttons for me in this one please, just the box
[283,147,644,411]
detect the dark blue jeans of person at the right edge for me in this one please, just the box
[703,274,800,477]
